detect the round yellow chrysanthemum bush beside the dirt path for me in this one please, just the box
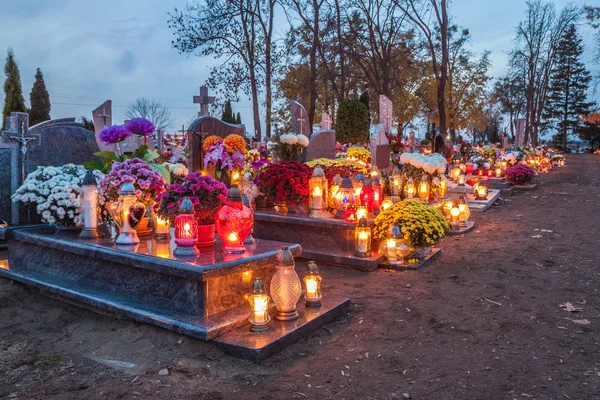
[373,200,450,247]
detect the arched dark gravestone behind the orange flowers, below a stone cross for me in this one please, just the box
[187,116,246,172]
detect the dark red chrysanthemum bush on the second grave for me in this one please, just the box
[254,161,312,206]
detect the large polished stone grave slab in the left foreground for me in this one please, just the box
[0,228,302,340]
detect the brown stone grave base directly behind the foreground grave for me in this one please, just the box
[252,210,383,271]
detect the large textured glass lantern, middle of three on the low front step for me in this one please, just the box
[271,246,302,321]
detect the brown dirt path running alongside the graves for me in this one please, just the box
[0,155,600,400]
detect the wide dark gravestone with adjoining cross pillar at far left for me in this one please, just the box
[0,113,100,225]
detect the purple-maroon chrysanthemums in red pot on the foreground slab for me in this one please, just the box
[154,172,227,247]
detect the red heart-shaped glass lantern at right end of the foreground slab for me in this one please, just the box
[215,185,254,254]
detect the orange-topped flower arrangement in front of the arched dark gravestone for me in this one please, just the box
[202,133,246,184]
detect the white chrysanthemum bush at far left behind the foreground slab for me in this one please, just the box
[12,164,104,227]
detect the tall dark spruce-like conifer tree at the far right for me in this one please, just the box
[544,25,591,151]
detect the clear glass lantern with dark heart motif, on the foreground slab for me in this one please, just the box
[109,182,146,245]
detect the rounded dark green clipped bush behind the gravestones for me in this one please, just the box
[336,100,370,143]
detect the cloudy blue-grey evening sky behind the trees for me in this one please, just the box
[0,0,600,136]
